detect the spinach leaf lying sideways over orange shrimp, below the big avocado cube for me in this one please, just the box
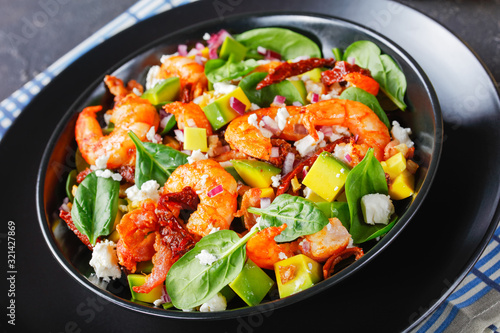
[248,194,328,242]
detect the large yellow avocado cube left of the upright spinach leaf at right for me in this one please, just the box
[302,151,350,202]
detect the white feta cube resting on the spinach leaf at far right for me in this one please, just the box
[361,193,394,225]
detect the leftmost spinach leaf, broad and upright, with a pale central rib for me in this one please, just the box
[71,172,120,244]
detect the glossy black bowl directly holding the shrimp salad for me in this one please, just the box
[37,13,443,319]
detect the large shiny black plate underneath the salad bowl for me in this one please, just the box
[0,0,500,332]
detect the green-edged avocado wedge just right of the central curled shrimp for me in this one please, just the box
[231,160,281,188]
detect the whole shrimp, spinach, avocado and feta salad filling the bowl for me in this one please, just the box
[59,28,418,311]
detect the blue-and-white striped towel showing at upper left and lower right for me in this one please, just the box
[0,0,500,333]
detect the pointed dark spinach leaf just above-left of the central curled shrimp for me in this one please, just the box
[128,132,188,188]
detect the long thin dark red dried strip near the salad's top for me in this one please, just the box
[256,58,335,90]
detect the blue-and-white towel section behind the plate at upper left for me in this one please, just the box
[0,0,196,140]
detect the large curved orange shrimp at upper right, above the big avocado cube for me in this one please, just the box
[303,99,391,161]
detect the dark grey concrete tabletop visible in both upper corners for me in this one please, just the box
[0,0,500,100]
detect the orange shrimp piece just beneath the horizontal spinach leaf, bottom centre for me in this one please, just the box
[247,224,297,269]
